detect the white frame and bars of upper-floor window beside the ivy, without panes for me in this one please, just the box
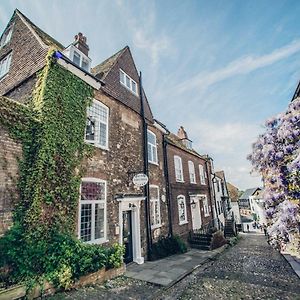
[84,99,109,150]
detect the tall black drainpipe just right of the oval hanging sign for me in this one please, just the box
[139,72,152,258]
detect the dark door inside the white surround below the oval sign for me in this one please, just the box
[123,210,133,264]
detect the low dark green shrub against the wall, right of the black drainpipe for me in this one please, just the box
[151,235,187,260]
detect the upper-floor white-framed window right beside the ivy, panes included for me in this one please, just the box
[85,99,109,149]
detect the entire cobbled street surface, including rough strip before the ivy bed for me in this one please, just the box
[50,233,300,300]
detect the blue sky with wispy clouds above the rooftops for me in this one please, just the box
[0,0,300,190]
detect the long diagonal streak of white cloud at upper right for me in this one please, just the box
[177,40,300,93]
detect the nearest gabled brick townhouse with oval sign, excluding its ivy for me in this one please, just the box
[0,10,169,264]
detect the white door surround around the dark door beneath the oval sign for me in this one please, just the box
[117,196,145,265]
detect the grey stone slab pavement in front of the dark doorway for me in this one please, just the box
[125,245,226,286]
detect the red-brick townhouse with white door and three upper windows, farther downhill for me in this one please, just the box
[166,127,214,240]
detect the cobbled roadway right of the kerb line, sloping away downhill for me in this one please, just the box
[155,234,300,300]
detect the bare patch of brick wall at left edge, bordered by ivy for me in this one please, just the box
[0,127,22,235]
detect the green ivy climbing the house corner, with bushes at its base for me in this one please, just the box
[0,51,124,288]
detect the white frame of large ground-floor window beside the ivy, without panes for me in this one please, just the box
[78,177,108,244]
